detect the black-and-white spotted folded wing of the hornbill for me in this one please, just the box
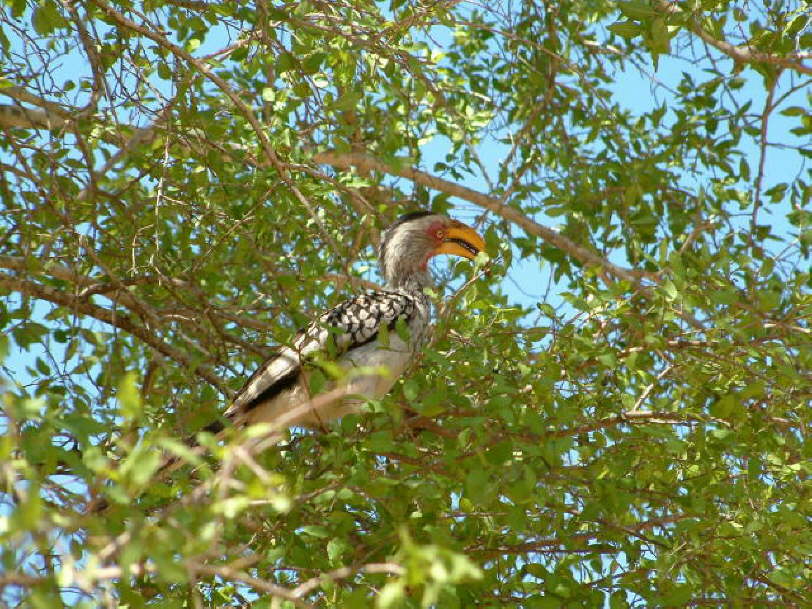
[219,290,416,420]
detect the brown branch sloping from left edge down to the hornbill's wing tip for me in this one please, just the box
[0,273,231,396]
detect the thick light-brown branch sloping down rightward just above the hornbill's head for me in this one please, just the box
[314,152,647,284]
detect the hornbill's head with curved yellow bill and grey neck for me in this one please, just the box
[380,211,485,287]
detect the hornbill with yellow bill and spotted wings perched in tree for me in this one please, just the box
[213,211,485,432]
